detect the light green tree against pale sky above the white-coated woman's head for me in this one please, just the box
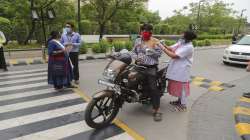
[167,0,241,34]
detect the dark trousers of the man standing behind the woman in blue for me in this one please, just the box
[69,52,79,81]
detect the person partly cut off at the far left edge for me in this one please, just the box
[0,31,8,71]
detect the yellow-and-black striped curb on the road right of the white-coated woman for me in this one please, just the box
[190,76,235,92]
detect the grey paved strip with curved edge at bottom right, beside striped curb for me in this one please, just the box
[188,76,250,140]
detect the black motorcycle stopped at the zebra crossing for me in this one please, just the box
[85,49,167,129]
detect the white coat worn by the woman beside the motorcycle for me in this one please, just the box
[166,42,194,82]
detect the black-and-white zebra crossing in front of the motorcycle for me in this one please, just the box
[0,69,137,140]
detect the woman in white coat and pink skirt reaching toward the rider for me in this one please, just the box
[161,31,197,111]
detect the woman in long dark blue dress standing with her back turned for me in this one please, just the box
[48,31,75,90]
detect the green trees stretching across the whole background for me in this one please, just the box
[0,0,246,44]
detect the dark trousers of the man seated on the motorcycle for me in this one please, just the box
[145,67,161,109]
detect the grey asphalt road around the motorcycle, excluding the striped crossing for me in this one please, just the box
[3,49,250,140]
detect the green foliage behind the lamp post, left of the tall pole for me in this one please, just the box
[0,0,75,44]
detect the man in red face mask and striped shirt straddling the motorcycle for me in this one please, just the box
[132,24,162,121]
